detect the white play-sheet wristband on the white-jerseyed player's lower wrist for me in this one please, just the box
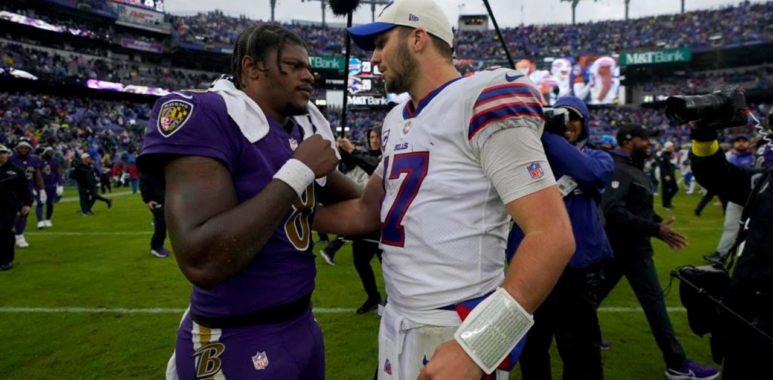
[454,288,534,374]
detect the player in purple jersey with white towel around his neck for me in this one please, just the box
[138,25,359,379]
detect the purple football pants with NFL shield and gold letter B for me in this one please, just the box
[175,310,325,380]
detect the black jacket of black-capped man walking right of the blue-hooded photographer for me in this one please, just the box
[601,150,663,258]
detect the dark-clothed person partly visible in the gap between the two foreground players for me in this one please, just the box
[337,128,382,314]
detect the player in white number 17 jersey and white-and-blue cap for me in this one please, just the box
[314,0,574,380]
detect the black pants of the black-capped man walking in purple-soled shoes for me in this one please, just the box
[602,250,687,368]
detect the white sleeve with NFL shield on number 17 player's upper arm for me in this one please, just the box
[478,127,556,204]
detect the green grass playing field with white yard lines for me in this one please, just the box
[0,183,721,380]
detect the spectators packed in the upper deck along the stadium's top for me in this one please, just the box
[0,2,773,60]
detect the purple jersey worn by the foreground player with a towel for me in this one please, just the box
[138,92,316,317]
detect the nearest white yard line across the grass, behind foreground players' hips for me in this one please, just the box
[0,306,687,314]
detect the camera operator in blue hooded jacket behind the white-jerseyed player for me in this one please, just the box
[507,96,614,380]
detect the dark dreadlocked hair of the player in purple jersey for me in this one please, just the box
[231,24,308,89]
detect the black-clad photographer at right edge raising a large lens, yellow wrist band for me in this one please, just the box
[666,91,773,380]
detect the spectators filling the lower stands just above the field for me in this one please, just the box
[0,92,770,157]
